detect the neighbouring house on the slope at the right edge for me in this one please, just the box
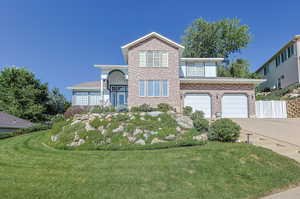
[256,35,300,89]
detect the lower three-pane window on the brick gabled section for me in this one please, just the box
[139,80,169,97]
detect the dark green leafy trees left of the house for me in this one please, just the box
[0,67,69,122]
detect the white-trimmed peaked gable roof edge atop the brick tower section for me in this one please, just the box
[121,32,184,64]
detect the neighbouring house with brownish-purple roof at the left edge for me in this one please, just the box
[0,112,33,132]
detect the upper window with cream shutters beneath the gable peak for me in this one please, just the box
[139,50,168,67]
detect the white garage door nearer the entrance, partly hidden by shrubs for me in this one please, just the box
[184,94,211,118]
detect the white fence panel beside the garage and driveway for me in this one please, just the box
[255,101,287,118]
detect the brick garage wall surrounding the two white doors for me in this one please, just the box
[180,83,255,118]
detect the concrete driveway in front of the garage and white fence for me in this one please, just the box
[234,118,300,146]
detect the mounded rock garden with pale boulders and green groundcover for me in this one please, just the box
[48,104,241,150]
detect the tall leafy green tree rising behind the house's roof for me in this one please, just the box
[182,18,250,58]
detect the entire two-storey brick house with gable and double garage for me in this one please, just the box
[68,32,263,118]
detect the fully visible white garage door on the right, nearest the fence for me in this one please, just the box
[222,94,248,118]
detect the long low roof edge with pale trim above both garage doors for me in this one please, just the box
[180,78,266,84]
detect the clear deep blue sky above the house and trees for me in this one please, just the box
[0,0,300,98]
